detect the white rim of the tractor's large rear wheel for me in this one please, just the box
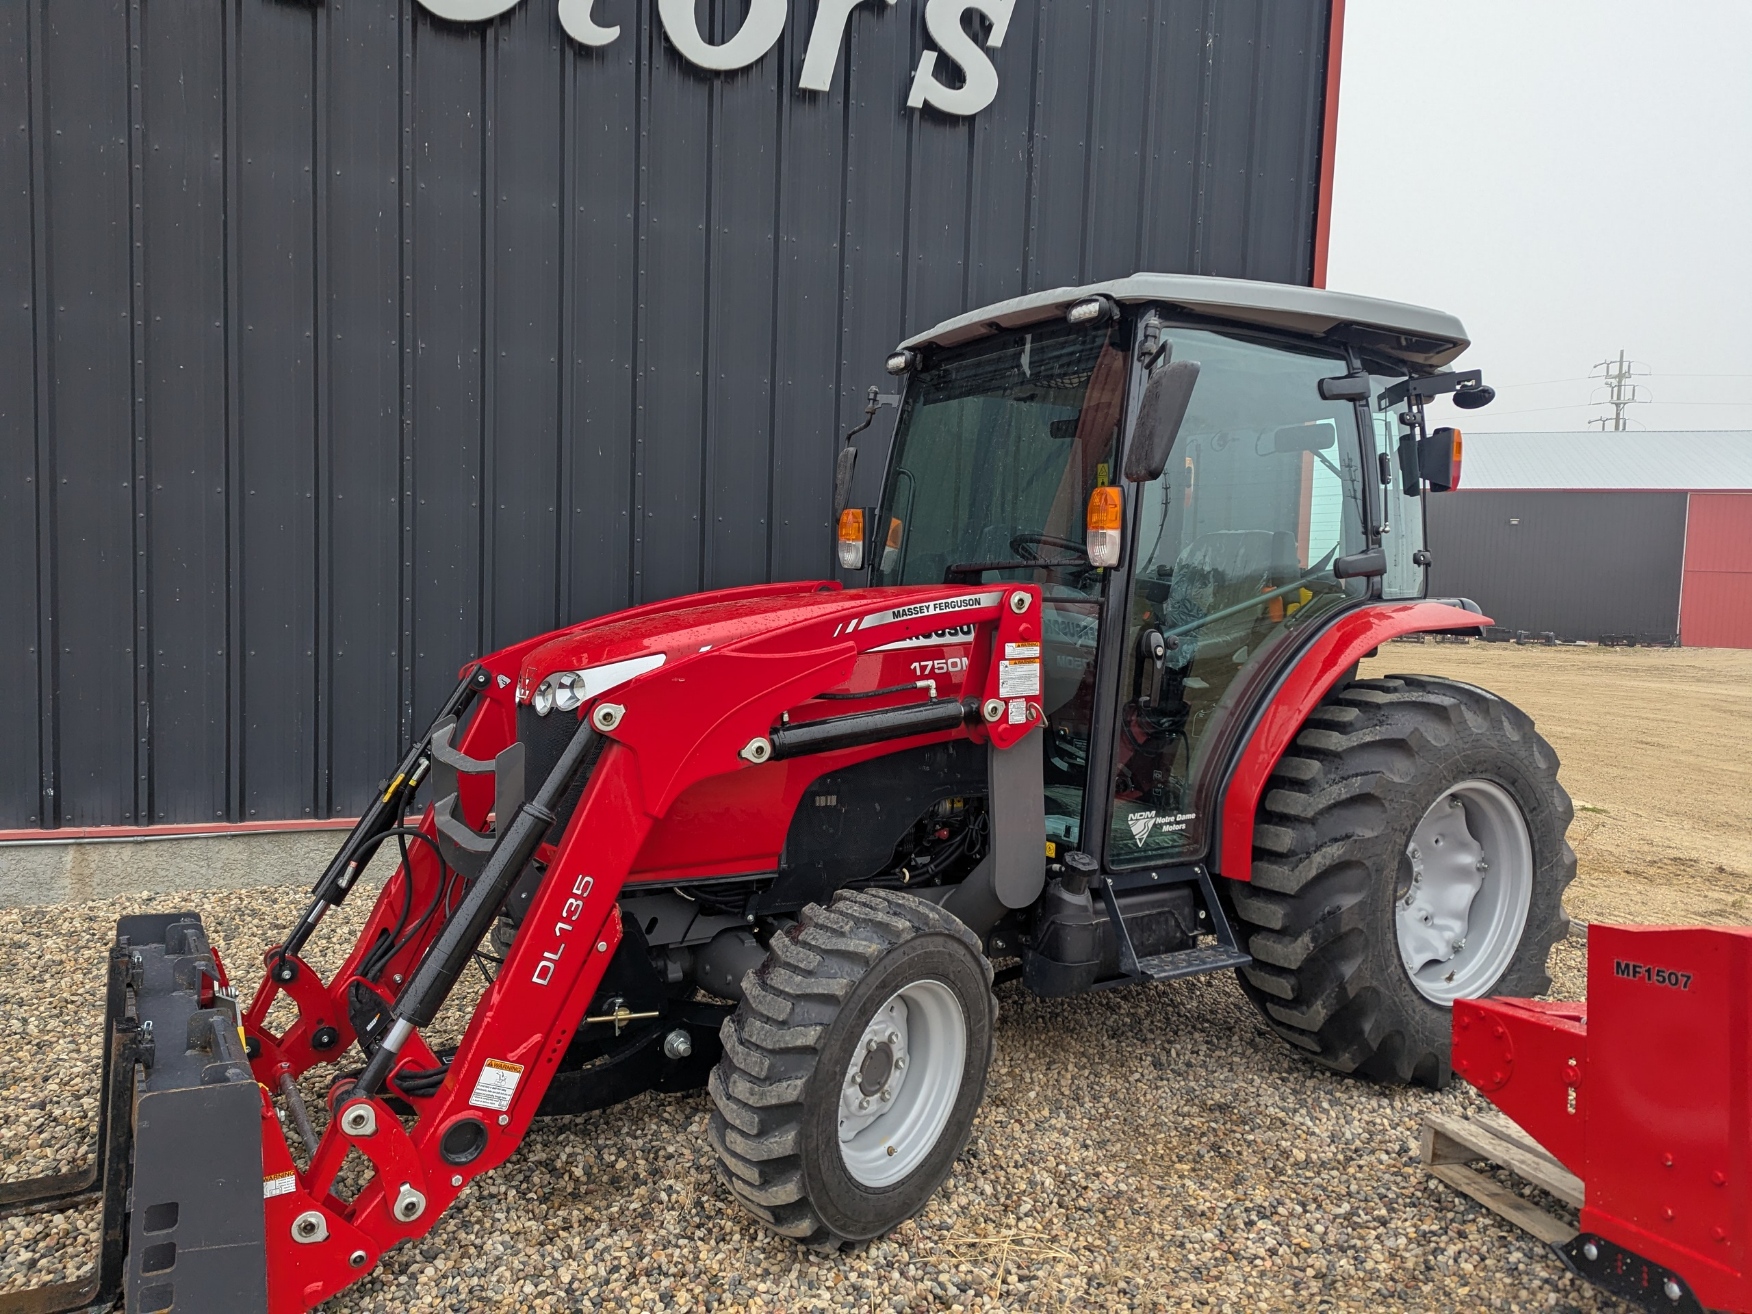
[1393,780,1533,1006]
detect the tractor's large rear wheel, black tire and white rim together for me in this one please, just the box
[1228,675,1575,1086]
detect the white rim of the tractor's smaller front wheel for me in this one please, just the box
[839,981,967,1186]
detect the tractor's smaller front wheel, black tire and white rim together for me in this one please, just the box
[710,890,997,1249]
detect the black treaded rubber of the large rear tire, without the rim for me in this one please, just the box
[1228,675,1575,1086]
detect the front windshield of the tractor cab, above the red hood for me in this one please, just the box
[872,324,1127,596]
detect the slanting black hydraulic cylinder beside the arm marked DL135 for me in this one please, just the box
[354,718,596,1097]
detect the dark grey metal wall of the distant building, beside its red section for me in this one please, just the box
[1426,492,1685,641]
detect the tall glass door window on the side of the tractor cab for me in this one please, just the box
[1107,329,1374,867]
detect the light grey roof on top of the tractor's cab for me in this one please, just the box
[901,273,1472,373]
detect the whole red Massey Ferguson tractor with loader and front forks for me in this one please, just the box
[4,275,1575,1314]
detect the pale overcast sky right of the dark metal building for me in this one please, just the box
[1326,0,1752,431]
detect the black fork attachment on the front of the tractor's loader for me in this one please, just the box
[0,913,268,1314]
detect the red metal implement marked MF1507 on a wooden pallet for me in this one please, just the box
[1454,925,1752,1310]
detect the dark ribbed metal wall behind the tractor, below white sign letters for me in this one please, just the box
[0,0,1328,827]
